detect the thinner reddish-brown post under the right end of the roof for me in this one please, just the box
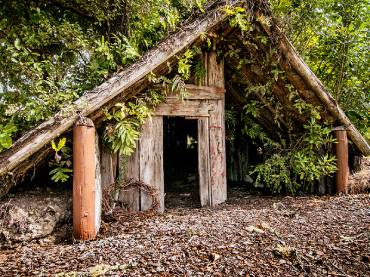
[333,127,349,193]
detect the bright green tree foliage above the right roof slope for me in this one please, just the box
[270,0,370,135]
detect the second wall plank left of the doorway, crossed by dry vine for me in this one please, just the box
[118,148,140,211]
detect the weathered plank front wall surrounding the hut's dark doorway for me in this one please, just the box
[102,52,227,212]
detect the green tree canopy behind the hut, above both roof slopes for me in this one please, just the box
[0,0,370,151]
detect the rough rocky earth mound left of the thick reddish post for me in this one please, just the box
[0,190,72,248]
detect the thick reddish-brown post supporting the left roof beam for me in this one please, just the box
[73,118,97,240]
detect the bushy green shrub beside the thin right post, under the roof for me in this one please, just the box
[247,117,336,194]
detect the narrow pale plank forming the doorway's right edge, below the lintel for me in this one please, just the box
[198,118,211,207]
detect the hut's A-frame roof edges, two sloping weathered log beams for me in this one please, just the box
[0,0,370,197]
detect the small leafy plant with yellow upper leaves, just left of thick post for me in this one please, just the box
[49,138,73,183]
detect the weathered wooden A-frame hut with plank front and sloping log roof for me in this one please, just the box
[0,1,370,235]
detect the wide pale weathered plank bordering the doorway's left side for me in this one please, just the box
[140,116,164,212]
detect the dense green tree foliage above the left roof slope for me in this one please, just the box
[0,0,205,151]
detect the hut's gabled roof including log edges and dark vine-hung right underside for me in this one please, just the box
[0,0,370,196]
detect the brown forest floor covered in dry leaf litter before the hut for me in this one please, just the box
[0,190,370,276]
